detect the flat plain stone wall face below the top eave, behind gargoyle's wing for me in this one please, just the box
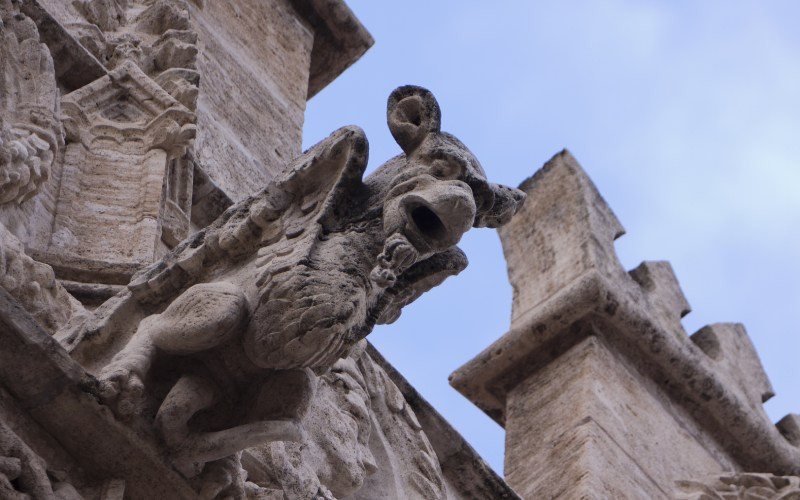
[192,0,314,201]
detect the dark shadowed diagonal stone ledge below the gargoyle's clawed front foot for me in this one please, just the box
[0,290,197,499]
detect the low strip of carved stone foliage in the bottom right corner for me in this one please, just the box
[676,472,800,500]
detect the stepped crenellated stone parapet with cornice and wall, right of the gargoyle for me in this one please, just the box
[451,151,800,498]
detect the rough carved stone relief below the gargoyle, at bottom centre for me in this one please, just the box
[243,341,445,499]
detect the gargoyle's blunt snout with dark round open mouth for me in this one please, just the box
[400,181,477,254]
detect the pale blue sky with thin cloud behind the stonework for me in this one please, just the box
[304,0,800,471]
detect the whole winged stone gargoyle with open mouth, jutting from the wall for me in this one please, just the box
[58,86,525,496]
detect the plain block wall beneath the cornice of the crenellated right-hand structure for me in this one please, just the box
[505,327,736,498]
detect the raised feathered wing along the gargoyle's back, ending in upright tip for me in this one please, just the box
[119,126,368,303]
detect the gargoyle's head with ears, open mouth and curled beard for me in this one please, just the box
[370,85,525,287]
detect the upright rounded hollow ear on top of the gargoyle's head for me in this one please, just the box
[386,85,442,154]
